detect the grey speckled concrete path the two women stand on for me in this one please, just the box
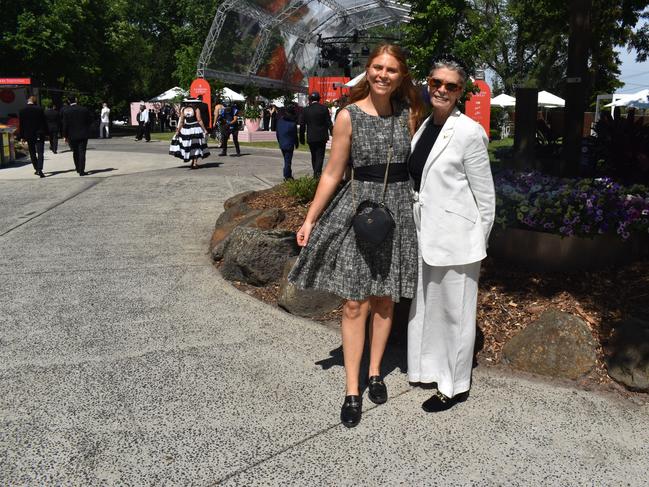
[0,139,649,486]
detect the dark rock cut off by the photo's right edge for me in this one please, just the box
[607,319,649,392]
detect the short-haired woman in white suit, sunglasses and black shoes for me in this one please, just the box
[408,56,496,412]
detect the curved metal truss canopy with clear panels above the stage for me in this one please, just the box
[196,0,410,92]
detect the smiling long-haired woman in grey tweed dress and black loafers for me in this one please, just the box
[289,45,422,427]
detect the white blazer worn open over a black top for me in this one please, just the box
[411,108,496,266]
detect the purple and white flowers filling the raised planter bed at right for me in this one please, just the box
[494,171,649,240]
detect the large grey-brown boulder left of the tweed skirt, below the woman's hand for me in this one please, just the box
[218,226,300,286]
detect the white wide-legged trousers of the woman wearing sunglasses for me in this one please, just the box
[408,200,481,397]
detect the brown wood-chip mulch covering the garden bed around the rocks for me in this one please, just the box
[229,186,649,402]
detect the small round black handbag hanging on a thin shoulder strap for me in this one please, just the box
[351,112,394,246]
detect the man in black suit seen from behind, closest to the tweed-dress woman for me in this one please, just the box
[300,91,332,178]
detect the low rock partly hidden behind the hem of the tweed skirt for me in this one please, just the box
[277,257,343,318]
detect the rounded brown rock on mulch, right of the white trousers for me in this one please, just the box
[503,309,597,379]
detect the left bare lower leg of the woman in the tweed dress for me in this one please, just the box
[342,301,369,396]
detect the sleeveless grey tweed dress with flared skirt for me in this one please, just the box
[288,105,417,302]
